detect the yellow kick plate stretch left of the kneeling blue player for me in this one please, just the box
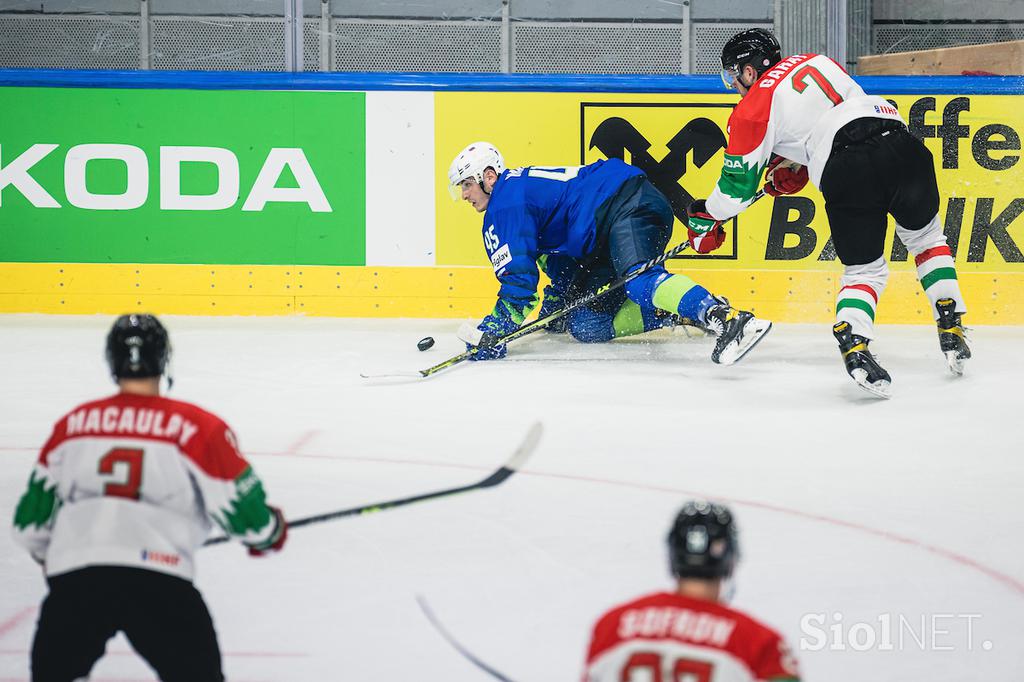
[0,263,498,317]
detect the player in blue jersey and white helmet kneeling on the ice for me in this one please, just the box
[449,142,771,365]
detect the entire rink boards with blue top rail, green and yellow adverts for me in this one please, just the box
[0,71,1024,325]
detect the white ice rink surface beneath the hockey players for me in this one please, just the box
[0,315,1024,682]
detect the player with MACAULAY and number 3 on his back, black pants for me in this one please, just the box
[13,315,288,682]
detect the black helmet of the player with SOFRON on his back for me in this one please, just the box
[669,500,739,580]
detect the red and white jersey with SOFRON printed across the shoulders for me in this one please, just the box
[583,592,800,682]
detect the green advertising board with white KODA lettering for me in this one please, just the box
[0,88,366,265]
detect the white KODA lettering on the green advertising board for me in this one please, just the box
[0,143,334,213]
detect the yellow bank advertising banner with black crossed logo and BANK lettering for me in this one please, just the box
[435,93,1024,272]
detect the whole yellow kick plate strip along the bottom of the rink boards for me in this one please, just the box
[0,263,1024,325]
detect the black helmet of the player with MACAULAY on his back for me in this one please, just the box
[106,314,171,380]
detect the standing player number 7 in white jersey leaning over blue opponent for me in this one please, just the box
[688,29,971,397]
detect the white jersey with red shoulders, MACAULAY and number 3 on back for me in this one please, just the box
[13,393,276,580]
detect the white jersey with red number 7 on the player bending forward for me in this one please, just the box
[707,54,903,220]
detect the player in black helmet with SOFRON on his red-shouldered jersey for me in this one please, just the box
[583,501,800,682]
